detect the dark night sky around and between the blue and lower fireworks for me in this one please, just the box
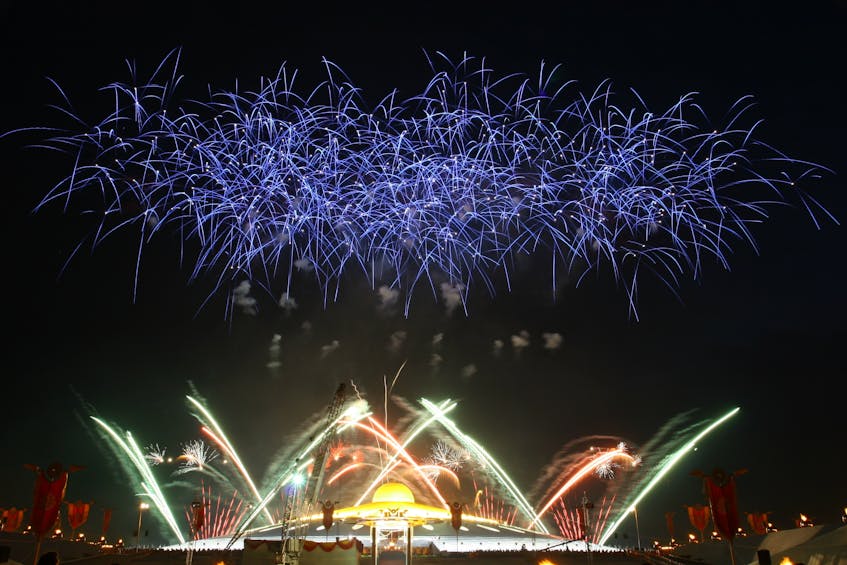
[0,1,847,539]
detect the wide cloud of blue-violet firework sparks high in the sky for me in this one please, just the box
[31,51,836,317]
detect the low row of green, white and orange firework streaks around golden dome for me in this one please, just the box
[84,386,737,544]
